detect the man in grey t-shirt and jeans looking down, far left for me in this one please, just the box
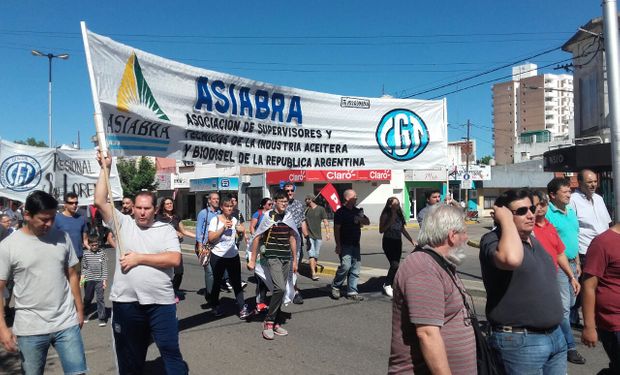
[0,190,88,374]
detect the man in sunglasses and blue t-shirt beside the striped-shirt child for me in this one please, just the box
[54,192,89,264]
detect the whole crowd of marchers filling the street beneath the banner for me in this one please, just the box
[0,159,620,374]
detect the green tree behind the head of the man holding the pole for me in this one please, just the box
[116,156,157,196]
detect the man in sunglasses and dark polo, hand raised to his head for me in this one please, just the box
[480,189,567,374]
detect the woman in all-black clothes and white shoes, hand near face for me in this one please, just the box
[379,197,416,298]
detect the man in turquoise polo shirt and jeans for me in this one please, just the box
[546,177,586,365]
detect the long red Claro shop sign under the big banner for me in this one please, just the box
[267,169,392,185]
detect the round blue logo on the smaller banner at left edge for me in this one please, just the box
[0,155,41,192]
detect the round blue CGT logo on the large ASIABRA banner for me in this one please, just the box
[375,109,430,161]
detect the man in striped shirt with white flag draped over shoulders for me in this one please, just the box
[247,190,299,340]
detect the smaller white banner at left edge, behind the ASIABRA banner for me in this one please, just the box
[0,141,123,205]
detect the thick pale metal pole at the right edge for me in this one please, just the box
[603,0,620,223]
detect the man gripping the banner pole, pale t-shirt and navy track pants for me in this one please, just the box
[95,155,189,374]
